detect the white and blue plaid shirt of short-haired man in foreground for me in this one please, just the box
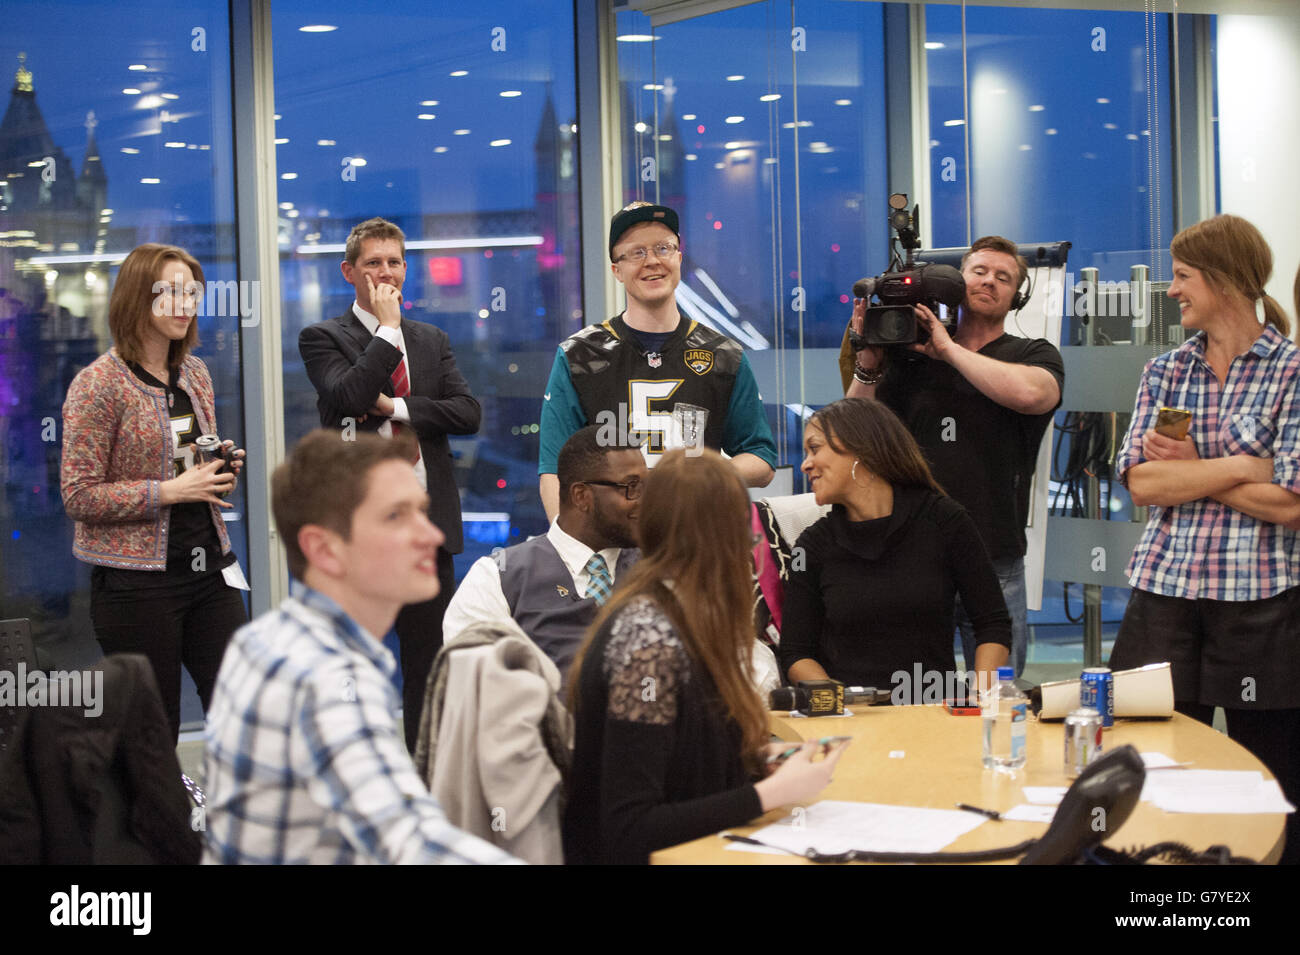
[204,585,515,864]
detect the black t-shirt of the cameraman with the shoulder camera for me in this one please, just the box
[876,334,1065,560]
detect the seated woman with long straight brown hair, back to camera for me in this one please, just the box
[564,450,842,863]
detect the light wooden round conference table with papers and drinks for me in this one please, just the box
[651,706,1286,865]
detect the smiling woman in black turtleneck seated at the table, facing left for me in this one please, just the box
[781,398,1011,703]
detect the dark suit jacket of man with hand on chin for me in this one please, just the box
[298,307,482,554]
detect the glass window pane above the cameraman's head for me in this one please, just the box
[926,4,1174,281]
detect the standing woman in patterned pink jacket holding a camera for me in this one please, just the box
[61,243,248,739]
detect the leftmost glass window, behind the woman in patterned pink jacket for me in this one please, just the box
[0,0,247,721]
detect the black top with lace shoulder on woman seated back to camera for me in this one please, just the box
[564,596,762,864]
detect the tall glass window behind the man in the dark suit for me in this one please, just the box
[273,0,584,566]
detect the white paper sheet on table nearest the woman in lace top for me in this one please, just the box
[728,799,996,855]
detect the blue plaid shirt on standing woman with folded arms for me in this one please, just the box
[1115,325,1300,600]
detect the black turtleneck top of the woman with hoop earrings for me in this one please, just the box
[780,487,1011,689]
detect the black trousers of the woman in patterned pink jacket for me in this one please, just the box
[90,573,248,741]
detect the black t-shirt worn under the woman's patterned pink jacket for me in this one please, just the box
[95,361,234,590]
